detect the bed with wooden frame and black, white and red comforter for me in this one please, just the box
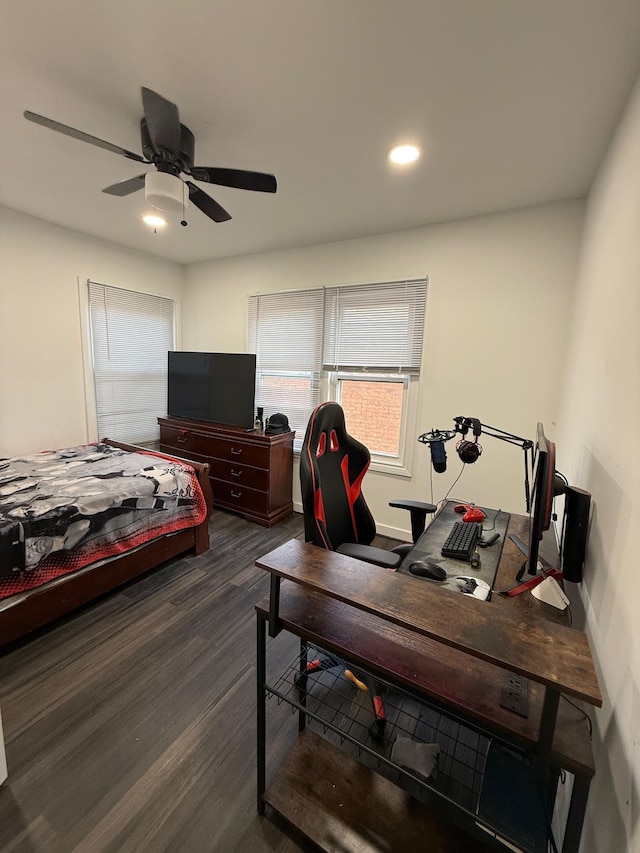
[0,439,213,647]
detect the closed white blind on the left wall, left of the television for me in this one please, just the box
[88,281,175,444]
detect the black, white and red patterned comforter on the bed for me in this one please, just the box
[0,443,207,599]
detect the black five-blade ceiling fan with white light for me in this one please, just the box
[24,86,277,225]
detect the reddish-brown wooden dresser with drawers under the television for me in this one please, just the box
[158,418,295,527]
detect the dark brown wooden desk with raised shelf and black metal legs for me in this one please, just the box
[256,518,601,853]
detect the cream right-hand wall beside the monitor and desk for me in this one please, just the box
[559,73,640,853]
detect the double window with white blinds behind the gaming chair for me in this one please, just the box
[249,279,427,471]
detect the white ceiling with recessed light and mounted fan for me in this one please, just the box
[0,0,640,263]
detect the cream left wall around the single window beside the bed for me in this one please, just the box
[0,208,183,456]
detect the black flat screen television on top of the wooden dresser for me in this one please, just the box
[167,352,256,429]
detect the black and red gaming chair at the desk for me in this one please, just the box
[300,402,436,569]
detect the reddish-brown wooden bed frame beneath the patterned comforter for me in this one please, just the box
[0,438,213,647]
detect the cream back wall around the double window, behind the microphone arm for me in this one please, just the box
[182,202,583,537]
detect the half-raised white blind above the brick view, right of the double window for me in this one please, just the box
[323,279,427,373]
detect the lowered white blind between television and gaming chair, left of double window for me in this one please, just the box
[249,288,324,443]
